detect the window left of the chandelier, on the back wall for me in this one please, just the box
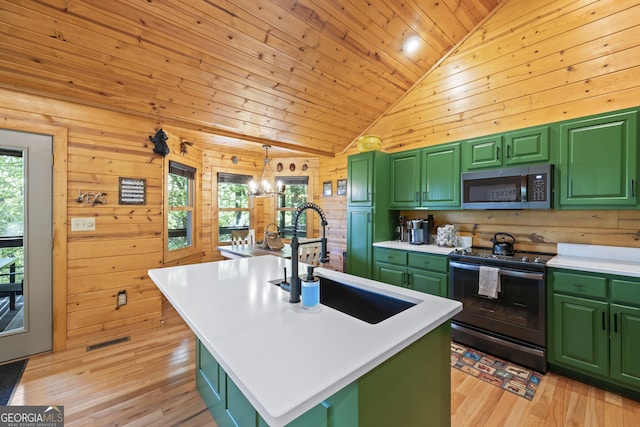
[218,173,252,242]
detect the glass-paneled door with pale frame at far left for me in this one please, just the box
[0,129,53,362]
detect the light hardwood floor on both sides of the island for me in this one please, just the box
[10,304,640,427]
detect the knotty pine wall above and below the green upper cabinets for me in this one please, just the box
[320,0,640,264]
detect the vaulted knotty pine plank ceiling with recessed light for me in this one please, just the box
[0,0,500,155]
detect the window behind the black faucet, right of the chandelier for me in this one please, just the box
[276,176,309,237]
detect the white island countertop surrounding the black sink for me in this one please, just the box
[149,256,462,427]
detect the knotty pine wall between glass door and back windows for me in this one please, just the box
[0,89,321,350]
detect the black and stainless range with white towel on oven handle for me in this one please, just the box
[449,248,554,372]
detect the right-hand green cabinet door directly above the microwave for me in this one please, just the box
[504,126,551,166]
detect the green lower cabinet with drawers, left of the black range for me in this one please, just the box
[374,247,449,297]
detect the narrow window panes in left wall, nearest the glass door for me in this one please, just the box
[167,161,196,251]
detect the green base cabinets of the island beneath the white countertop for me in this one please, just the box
[196,322,451,427]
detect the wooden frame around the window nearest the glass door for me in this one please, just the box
[163,156,202,262]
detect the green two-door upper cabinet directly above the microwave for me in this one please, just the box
[462,126,551,172]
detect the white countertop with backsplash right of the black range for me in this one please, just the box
[547,243,640,277]
